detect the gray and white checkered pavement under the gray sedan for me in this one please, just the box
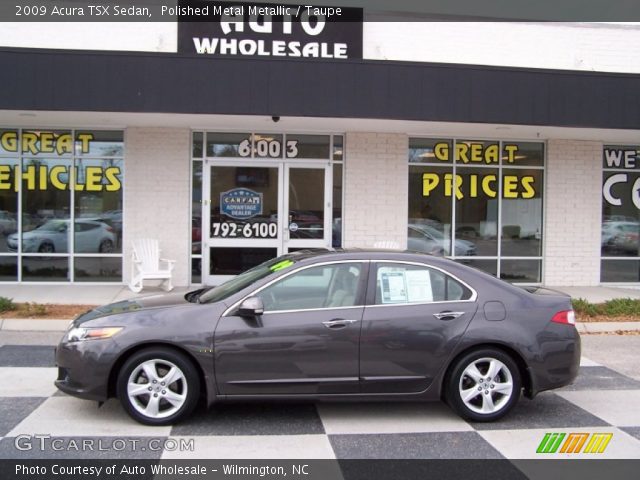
[0,345,640,459]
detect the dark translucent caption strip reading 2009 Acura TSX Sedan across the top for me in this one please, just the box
[0,0,640,23]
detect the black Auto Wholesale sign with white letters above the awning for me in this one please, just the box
[175,0,363,59]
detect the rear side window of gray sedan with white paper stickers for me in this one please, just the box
[375,263,471,305]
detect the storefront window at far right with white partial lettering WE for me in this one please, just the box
[600,145,640,283]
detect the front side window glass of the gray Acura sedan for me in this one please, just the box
[258,263,363,312]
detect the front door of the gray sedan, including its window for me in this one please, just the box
[214,261,368,395]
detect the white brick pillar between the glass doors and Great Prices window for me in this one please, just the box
[343,133,409,248]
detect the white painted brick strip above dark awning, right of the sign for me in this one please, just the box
[363,22,640,73]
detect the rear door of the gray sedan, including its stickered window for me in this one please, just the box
[360,261,477,393]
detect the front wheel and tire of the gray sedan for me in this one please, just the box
[117,347,200,425]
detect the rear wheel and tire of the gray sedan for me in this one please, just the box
[445,348,522,422]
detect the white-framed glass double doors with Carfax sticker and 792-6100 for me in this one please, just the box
[202,160,332,285]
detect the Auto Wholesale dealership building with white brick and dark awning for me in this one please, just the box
[0,2,640,289]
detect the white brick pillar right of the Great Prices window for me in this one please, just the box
[544,140,602,286]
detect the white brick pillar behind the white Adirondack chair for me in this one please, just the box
[123,128,191,286]
